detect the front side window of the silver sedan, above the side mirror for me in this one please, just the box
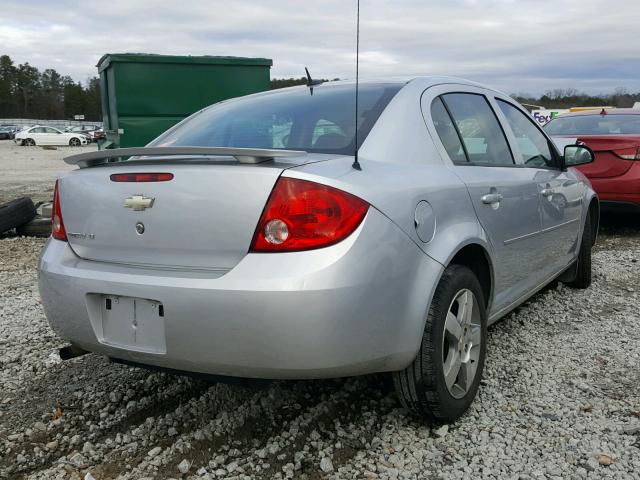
[496,99,555,167]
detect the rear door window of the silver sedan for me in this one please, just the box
[442,93,514,166]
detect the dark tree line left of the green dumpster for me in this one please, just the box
[0,55,102,121]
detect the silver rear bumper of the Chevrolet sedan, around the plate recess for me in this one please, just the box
[39,208,442,379]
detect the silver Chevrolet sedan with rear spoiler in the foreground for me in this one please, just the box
[39,77,599,422]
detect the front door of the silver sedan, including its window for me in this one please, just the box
[496,98,586,278]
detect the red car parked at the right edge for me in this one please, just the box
[544,108,640,213]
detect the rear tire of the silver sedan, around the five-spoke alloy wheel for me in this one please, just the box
[392,265,487,424]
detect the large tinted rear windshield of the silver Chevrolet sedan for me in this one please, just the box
[149,84,403,155]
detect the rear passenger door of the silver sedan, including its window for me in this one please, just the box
[423,86,541,313]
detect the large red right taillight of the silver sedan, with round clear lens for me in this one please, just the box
[251,178,369,252]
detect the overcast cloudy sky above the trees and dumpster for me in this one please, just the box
[0,0,640,94]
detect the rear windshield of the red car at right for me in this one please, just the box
[544,114,640,135]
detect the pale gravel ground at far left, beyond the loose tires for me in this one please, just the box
[0,140,97,204]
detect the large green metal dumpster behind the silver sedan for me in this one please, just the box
[97,53,273,148]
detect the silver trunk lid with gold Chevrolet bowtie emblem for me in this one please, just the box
[59,155,331,270]
